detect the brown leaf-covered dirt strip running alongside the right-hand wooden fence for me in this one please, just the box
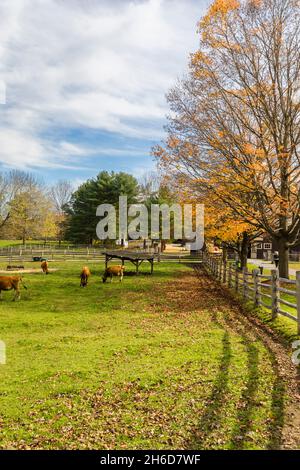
[190,267,300,449]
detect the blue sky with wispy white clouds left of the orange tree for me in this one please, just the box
[0,0,208,185]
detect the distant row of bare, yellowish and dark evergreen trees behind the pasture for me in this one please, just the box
[0,170,171,245]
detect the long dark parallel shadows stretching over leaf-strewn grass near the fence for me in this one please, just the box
[187,268,285,449]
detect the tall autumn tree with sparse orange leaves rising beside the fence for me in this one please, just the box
[154,0,300,277]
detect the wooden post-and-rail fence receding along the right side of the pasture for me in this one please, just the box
[203,253,300,334]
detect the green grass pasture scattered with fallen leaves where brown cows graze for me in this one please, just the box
[0,262,294,449]
